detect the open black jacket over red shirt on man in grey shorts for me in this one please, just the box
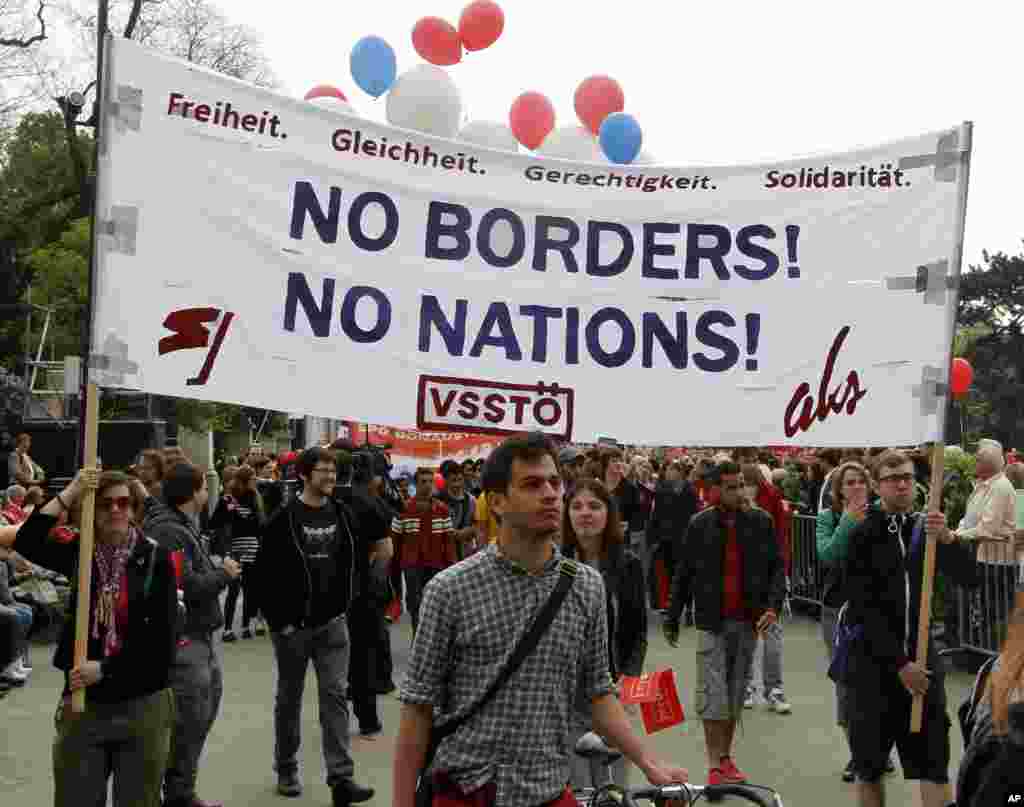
[666,507,785,633]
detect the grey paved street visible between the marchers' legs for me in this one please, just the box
[0,617,972,807]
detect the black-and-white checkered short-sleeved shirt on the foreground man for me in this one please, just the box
[398,546,614,807]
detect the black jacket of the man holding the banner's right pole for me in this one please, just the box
[841,507,978,686]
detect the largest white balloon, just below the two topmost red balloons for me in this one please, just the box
[387,65,462,137]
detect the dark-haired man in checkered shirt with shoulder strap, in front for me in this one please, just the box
[392,434,687,807]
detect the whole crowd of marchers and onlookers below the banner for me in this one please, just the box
[0,434,1024,807]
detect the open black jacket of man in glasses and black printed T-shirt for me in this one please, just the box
[252,498,357,632]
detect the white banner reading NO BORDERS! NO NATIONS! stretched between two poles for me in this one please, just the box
[93,39,970,445]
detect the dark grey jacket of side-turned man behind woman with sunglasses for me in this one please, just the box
[142,496,230,636]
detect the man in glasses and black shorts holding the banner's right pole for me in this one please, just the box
[829,451,977,807]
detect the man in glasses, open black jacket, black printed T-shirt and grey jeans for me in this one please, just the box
[255,448,391,807]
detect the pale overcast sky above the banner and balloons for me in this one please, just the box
[216,0,1024,263]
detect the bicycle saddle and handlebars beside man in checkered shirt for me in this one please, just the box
[572,731,783,807]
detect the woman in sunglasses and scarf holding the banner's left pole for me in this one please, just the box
[0,471,177,807]
